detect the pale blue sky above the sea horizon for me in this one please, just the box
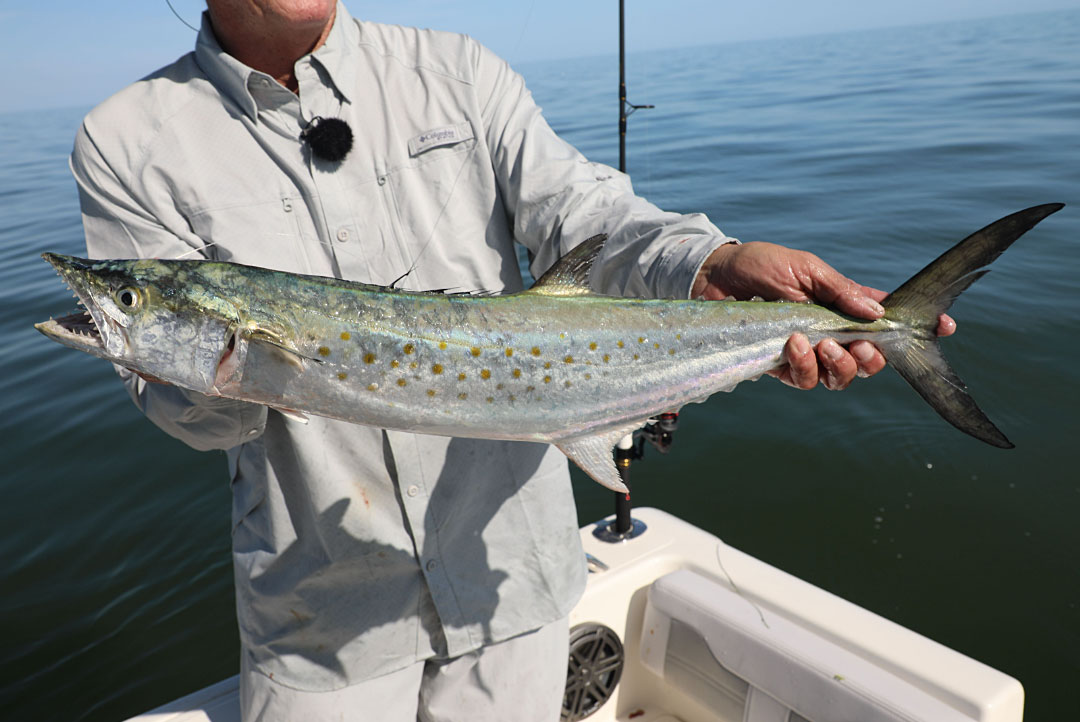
[6,0,1080,112]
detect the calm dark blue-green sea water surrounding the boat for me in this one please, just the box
[0,11,1080,720]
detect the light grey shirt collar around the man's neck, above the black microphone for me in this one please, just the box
[195,2,360,120]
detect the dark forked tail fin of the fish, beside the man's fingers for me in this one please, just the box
[880,203,1065,449]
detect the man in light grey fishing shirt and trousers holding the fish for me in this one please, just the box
[71,0,951,721]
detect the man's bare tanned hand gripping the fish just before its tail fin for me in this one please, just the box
[691,243,956,390]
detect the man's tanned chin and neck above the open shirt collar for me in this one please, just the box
[210,3,336,93]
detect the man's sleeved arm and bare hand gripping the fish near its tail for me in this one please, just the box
[468,40,956,389]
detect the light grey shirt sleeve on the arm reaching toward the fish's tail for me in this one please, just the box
[476,40,737,298]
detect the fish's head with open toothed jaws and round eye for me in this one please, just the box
[36,254,238,394]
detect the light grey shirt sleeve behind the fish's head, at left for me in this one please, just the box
[70,119,267,450]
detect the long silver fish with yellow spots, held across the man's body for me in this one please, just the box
[36,203,1064,492]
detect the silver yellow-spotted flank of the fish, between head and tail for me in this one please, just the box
[236,294,876,441]
